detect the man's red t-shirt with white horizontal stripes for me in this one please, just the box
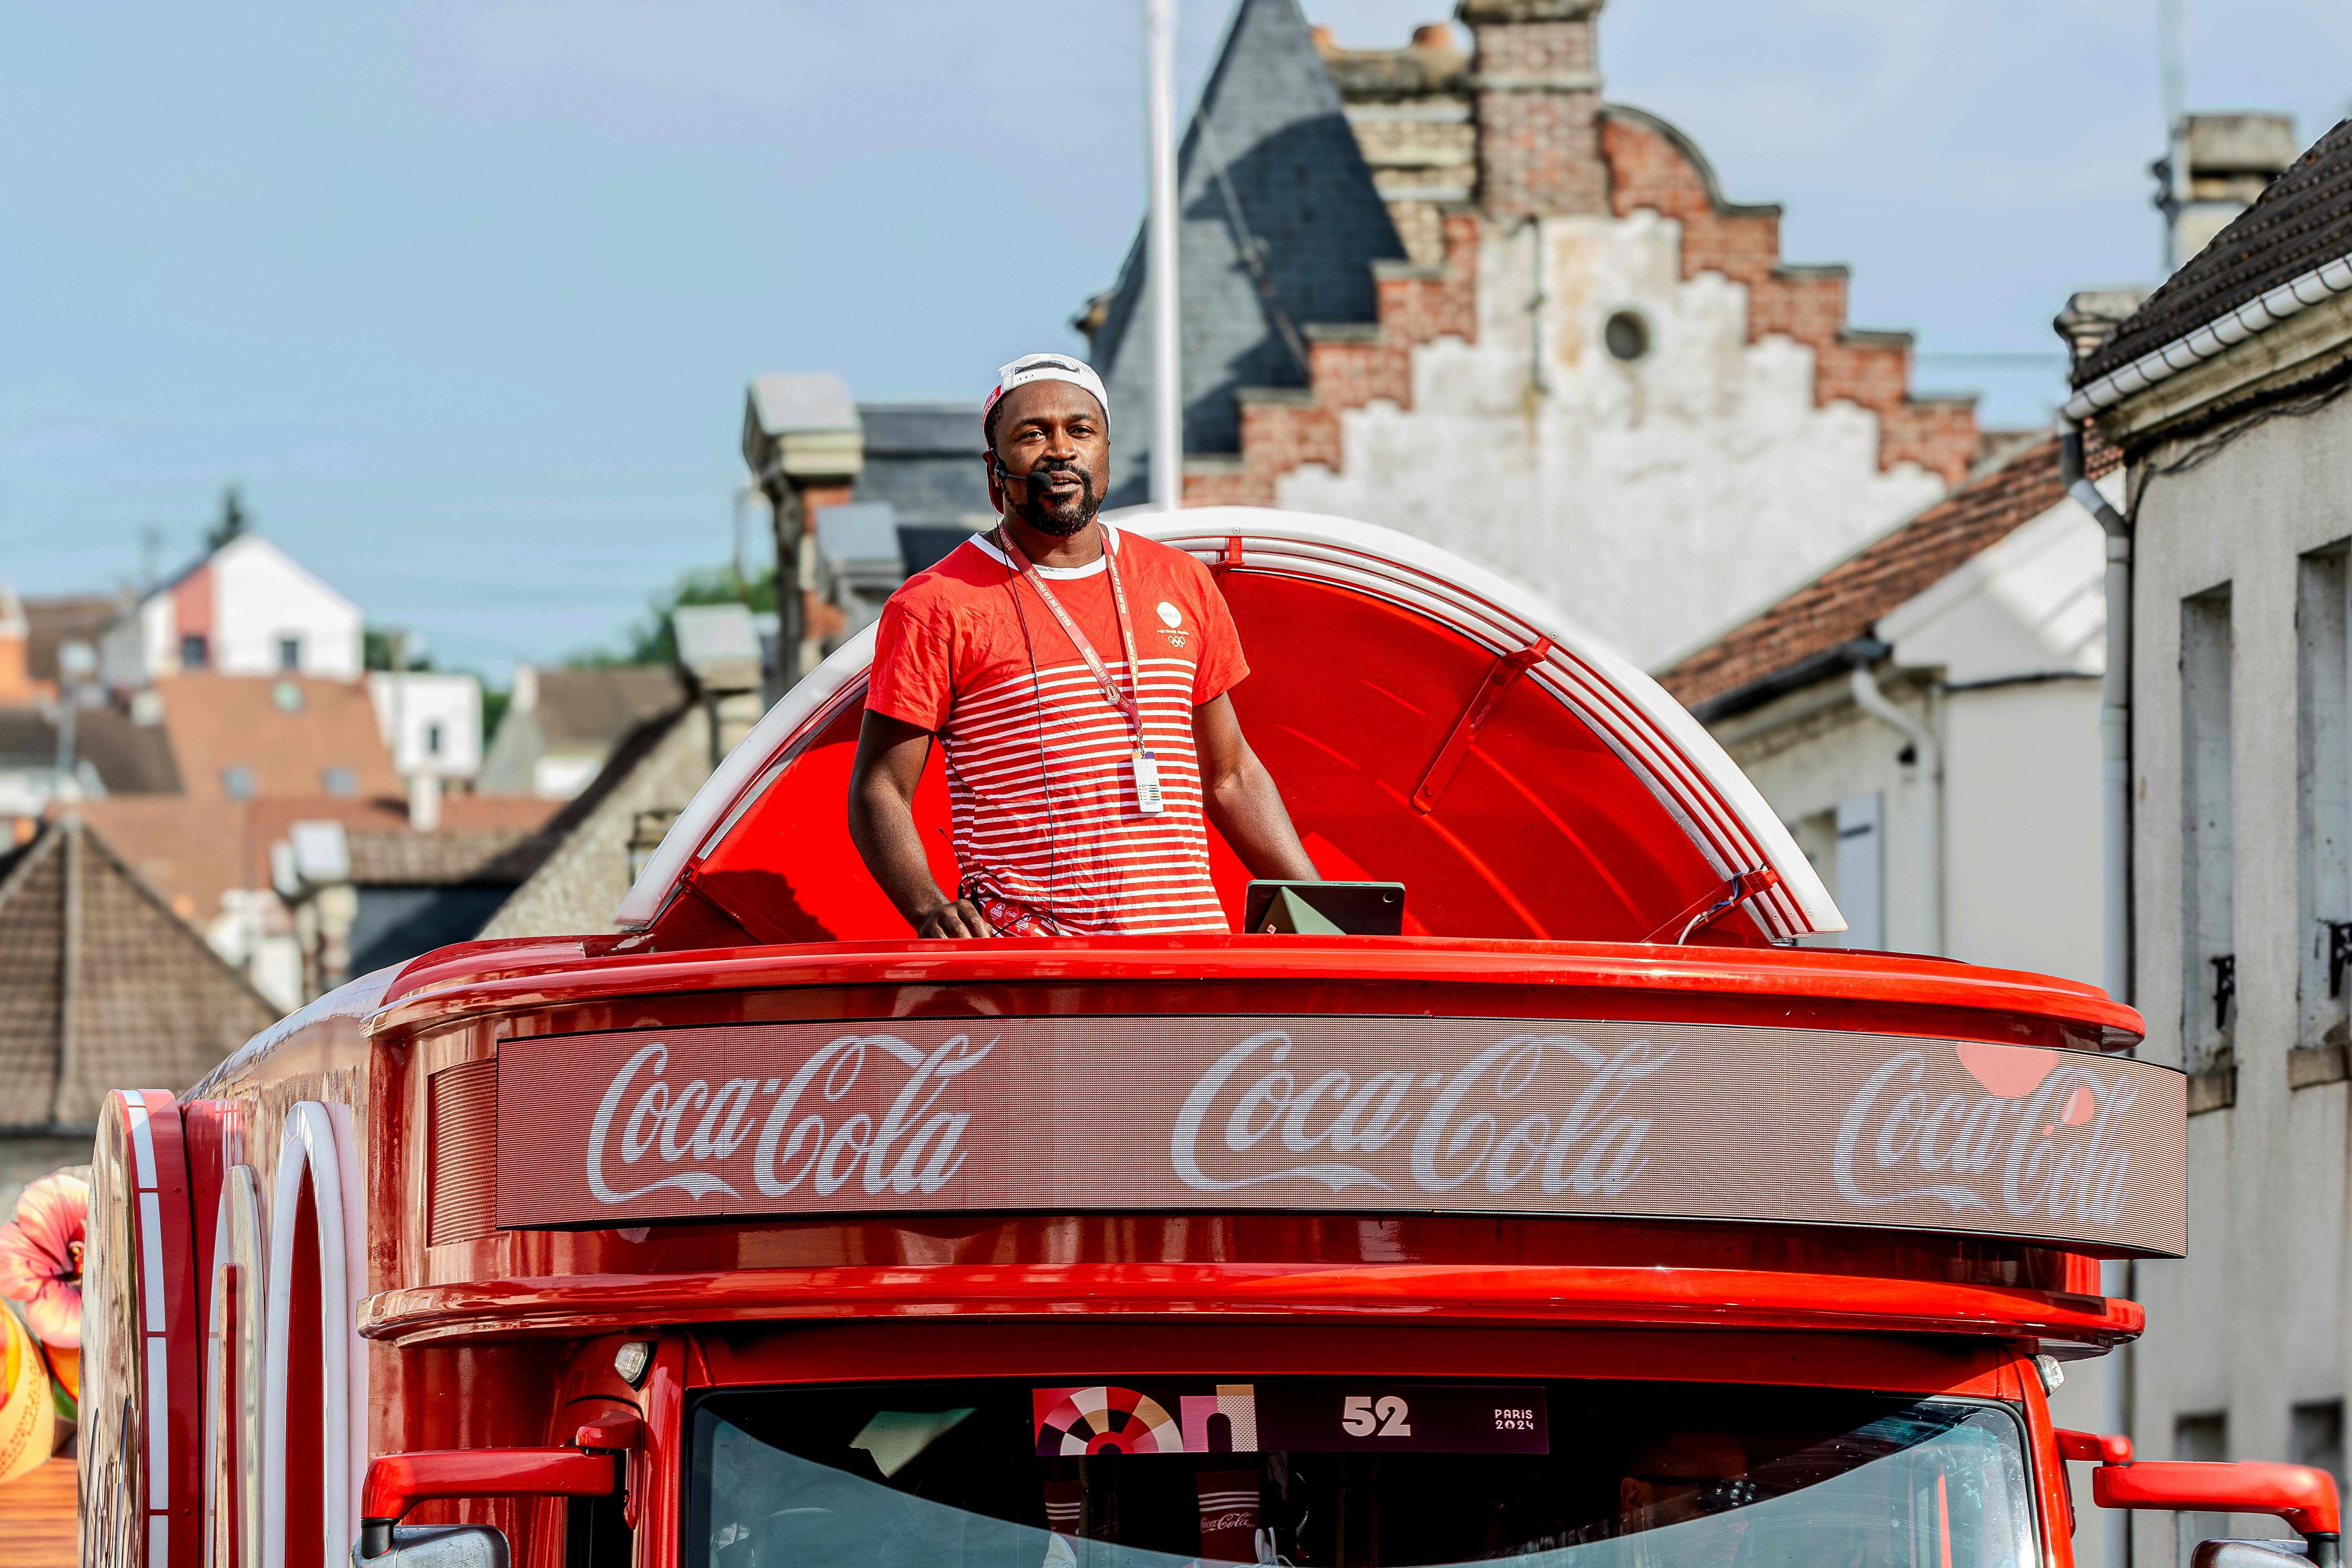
[866,522,1249,933]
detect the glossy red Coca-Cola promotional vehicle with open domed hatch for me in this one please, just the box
[82,508,2338,1568]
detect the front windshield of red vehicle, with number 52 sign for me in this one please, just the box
[687,1377,2037,1568]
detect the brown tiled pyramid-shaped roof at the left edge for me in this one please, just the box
[0,818,278,1131]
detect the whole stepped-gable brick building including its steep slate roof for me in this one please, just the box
[1080,0,1980,665]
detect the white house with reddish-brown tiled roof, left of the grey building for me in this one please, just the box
[1661,437,2124,1563]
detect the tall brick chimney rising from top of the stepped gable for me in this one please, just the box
[1458,0,1609,219]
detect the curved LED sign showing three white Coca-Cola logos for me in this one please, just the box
[499,1016,2187,1255]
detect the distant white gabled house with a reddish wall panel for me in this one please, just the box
[101,534,360,689]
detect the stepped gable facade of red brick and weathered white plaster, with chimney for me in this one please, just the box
[1148,0,1980,665]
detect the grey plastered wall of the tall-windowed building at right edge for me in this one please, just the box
[2133,381,2352,1568]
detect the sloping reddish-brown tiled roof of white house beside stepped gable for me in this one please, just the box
[1658,435,2122,722]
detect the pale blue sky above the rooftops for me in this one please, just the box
[0,0,2352,684]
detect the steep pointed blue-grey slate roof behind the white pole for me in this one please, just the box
[1091,0,1404,505]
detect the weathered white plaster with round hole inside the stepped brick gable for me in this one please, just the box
[1277,212,1943,668]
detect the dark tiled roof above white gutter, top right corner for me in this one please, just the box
[2074,120,2352,386]
